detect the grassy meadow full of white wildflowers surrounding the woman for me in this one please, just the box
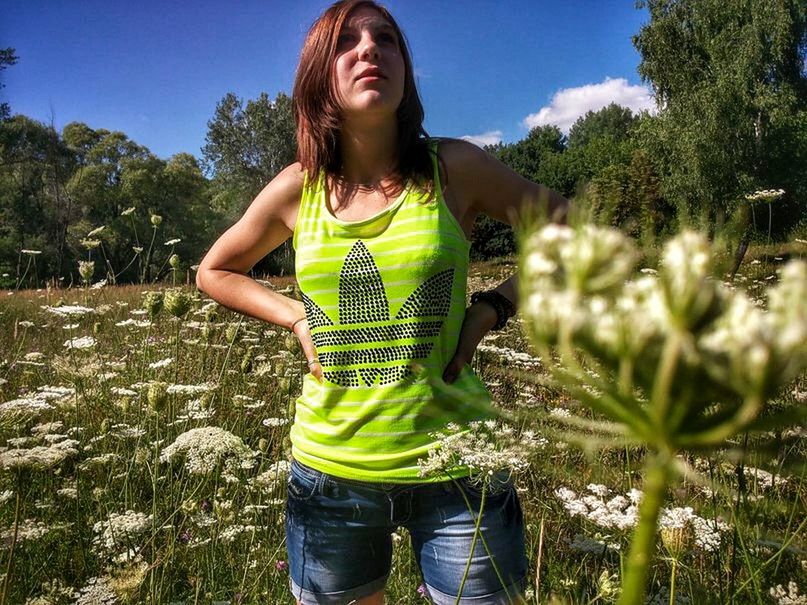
[0,245,807,605]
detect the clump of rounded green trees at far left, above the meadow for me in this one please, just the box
[0,115,219,287]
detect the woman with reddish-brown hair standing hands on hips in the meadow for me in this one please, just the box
[197,0,567,605]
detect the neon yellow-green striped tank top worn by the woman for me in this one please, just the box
[291,144,490,483]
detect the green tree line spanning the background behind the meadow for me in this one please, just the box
[0,0,807,287]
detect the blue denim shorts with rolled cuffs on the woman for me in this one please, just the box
[286,461,527,605]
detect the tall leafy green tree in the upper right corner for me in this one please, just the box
[634,0,807,231]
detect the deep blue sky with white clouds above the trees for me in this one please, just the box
[0,0,652,158]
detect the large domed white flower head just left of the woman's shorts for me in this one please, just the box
[160,426,257,482]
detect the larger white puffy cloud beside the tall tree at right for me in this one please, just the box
[523,78,656,132]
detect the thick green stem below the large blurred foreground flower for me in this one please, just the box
[617,452,673,605]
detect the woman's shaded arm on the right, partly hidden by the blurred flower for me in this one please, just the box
[439,139,569,383]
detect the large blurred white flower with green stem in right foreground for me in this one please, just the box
[520,225,807,605]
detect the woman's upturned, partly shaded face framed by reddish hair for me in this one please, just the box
[334,6,404,118]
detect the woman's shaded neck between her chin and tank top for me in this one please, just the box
[340,120,398,187]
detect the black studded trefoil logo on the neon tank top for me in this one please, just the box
[302,240,454,387]
